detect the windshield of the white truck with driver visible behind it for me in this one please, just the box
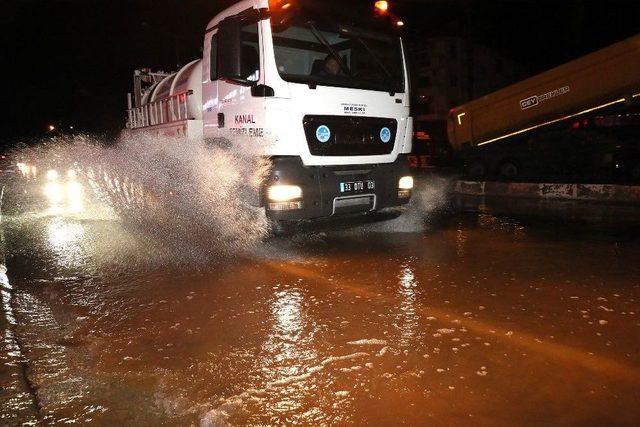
[272,15,404,93]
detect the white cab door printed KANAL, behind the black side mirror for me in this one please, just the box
[217,19,265,140]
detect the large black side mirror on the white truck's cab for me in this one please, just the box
[218,17,255,86]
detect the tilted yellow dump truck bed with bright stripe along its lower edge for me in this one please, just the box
[448,34,640,149]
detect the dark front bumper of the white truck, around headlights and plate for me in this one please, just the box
[262,155,411,221]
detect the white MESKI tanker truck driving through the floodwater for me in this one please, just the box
[125,0,413,226]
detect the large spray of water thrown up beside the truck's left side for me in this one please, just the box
[11,134,269,261]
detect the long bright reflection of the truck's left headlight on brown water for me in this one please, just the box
[200,282,331,426]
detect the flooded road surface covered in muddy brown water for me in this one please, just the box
[0,193,640,426]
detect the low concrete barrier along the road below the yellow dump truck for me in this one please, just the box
[453,181,640,204]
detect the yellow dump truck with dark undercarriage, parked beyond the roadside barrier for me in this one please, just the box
[447,35,640,180]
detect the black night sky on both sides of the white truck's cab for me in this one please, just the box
[0,0,640,146]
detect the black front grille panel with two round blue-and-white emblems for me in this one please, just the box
[302,116,398,156]
